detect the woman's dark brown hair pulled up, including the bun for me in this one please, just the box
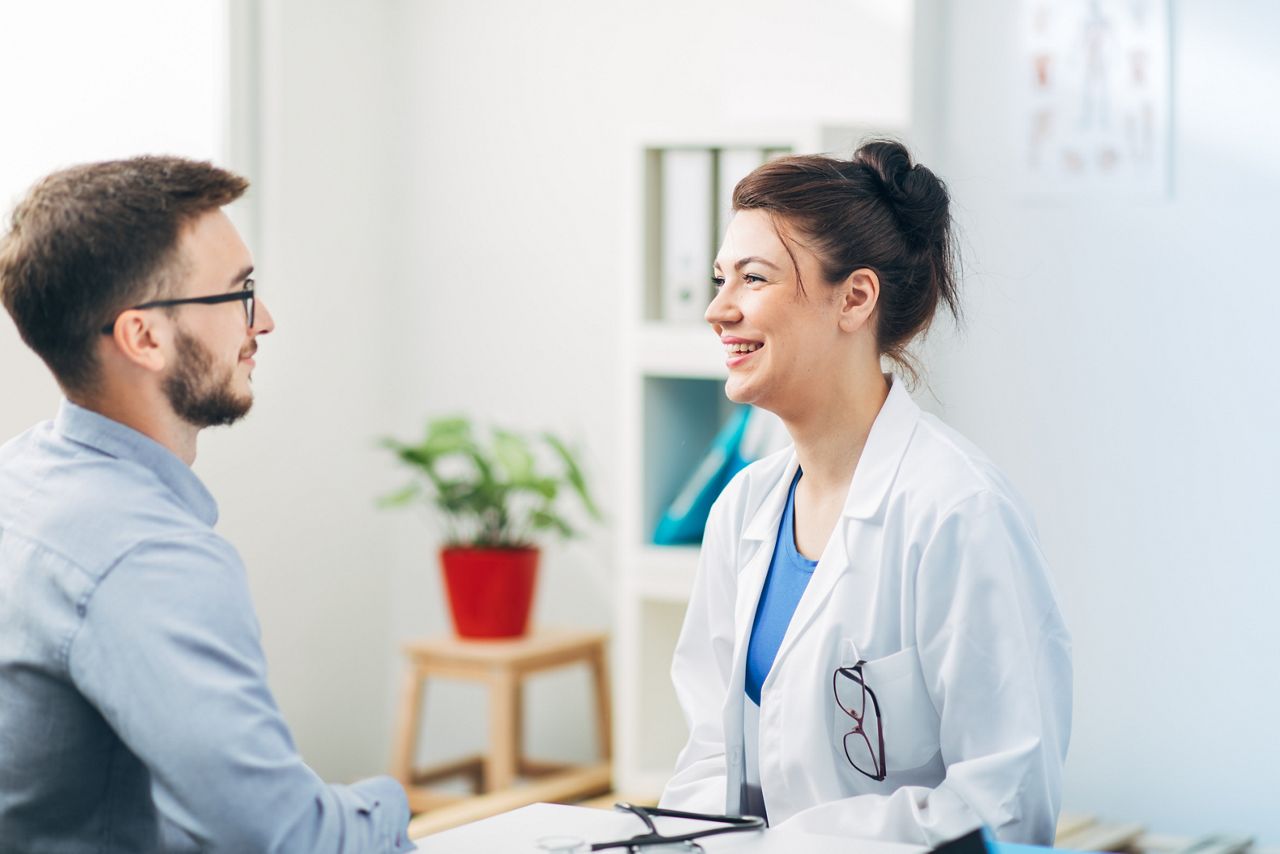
[733,140,960,380]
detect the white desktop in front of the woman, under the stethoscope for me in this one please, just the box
[417,804,925,854]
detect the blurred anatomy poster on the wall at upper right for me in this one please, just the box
[1019,0,1170,197]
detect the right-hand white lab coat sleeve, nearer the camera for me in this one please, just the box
[782,493,1071,846]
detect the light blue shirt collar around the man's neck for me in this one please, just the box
[54,399,218,528]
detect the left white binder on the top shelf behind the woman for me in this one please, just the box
[662,149,716,321]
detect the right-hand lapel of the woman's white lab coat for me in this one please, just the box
[771,376,920,676]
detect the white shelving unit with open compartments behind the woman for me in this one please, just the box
[614,125,884,798]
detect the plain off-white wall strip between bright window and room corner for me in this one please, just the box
[196,0,403,780]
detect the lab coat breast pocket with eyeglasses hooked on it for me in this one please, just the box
[833,647,941,775]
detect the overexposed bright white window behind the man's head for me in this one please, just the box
[0,0,227,442]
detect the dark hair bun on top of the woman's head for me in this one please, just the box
[854,140,951,246]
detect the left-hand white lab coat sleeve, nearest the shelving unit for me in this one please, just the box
[660,483,737,813]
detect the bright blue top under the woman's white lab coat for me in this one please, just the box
[746,470,818,705]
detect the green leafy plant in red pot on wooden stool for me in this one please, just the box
[379,417,600,638]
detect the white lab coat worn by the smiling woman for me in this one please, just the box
[662,379,1071,846]
